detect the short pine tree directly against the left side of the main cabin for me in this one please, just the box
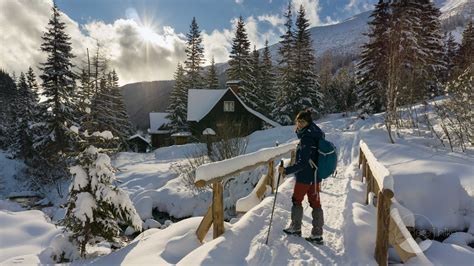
[166,63,188,132]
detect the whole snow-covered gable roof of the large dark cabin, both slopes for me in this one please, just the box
[187,89,280,127]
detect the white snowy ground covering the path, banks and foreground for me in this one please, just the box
[0,109,474,265]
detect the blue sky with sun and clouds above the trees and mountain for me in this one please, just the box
[0,0,376,85]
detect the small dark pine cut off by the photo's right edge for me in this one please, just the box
[456,19,474,73]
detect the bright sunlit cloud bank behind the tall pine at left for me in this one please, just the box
[0,0,185,84]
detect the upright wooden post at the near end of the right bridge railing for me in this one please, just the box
[374,189,393,265]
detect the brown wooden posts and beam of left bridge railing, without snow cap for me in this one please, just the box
[195,144,296,243]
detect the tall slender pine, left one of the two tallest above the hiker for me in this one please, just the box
[272,3,294,125]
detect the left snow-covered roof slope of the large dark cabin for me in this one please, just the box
[187,89,227,122]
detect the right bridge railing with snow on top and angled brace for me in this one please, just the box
[359,140,426,265]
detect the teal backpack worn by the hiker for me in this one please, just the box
[309,138,337,182]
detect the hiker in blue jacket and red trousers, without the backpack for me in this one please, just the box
[278,110,324,244]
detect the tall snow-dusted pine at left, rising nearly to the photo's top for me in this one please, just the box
[30,5,76,181]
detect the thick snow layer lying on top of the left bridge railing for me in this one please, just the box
[196,142,297,182]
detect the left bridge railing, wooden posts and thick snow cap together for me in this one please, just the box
[195,142,297,242]
